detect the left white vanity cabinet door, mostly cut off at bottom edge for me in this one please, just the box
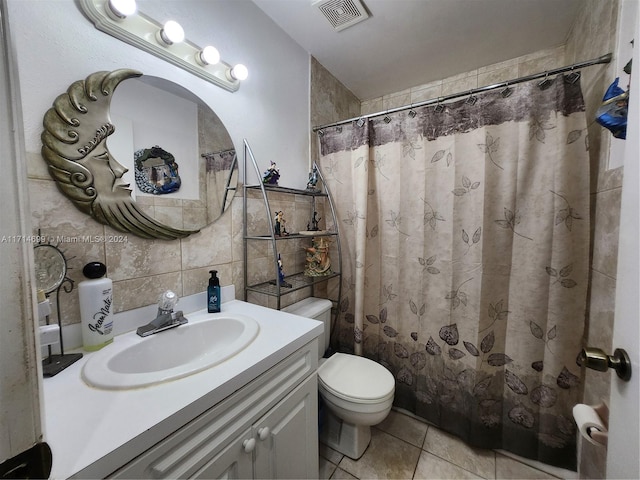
[191,429,255,479]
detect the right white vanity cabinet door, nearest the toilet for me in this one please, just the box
[253,373,318,479]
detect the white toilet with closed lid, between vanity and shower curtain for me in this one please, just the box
[282,297,395,460]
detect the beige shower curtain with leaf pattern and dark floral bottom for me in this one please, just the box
[319,76,589,469]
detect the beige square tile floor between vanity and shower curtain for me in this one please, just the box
[320,411,572,480]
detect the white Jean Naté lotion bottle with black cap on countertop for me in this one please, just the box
[78,262,113,352]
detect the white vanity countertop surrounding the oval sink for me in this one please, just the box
[43,294,323,479]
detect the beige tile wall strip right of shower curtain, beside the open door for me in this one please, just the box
[566,0,623,478]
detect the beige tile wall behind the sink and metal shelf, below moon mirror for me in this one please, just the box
[28,154,337,326]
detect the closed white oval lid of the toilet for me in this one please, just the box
[318,353,395,401]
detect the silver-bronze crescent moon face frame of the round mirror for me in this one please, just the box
[41,69,238,240]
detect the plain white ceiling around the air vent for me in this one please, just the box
[253,0,582,100]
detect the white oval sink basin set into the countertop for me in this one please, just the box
[82,313,260,390]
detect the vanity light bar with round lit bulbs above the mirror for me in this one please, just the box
[79,0,246,92]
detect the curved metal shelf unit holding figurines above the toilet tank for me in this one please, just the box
[242,139,342,315]
